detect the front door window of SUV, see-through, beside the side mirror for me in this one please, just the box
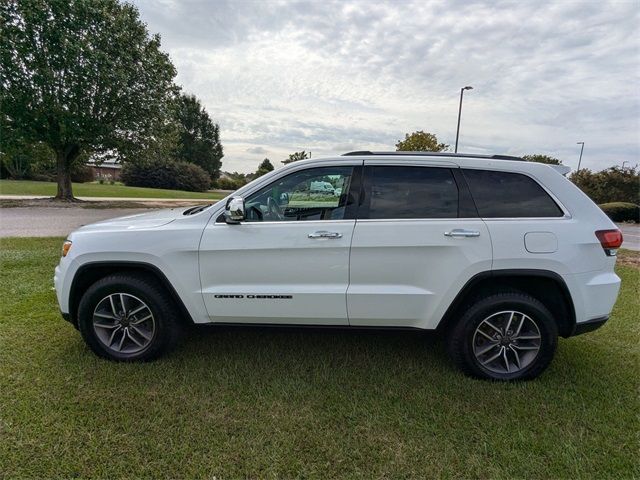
[245,167,353,222]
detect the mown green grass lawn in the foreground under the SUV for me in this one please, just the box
[0,239,640,478]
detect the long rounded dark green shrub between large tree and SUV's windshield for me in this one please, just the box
[121,160,211,192]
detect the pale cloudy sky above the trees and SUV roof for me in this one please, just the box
[134,0,640,173]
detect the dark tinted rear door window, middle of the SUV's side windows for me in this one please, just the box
[363,166,458,219]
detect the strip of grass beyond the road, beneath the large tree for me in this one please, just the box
[0,180,224,200]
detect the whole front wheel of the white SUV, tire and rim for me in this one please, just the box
[78,275,180,361]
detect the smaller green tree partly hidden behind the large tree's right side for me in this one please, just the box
[174,94,223,180]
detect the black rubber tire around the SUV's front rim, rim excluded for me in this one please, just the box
[78,274,182,362]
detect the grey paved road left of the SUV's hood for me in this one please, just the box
[0,207,149,237]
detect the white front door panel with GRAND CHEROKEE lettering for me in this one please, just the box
[200,220,355,325]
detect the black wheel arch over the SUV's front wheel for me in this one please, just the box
[69,262,194,328]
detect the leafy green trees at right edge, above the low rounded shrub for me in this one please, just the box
[569,166,640,205]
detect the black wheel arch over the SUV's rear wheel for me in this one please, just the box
[437,269,576,337]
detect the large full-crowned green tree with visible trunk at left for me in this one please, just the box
[0,0,176,200]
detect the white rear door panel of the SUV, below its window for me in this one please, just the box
[347,219,491,328]
